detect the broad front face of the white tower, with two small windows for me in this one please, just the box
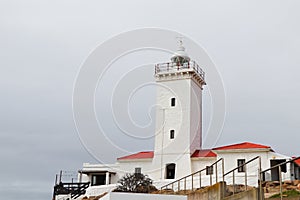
[152,76,191,180]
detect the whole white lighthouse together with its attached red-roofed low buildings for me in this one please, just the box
[74,44,293,195]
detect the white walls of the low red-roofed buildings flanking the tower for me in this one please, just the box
[77,149,291,196]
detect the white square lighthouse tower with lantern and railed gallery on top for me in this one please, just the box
[153,41,205,179]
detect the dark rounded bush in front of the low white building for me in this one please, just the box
[114,173,157,193]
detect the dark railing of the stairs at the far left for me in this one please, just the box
[53,182,90,199]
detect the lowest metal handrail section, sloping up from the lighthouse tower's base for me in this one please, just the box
[160,158,224,192]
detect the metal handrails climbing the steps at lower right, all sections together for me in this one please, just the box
[161,156,300,200]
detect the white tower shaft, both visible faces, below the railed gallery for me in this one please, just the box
[153,70,202,179]
